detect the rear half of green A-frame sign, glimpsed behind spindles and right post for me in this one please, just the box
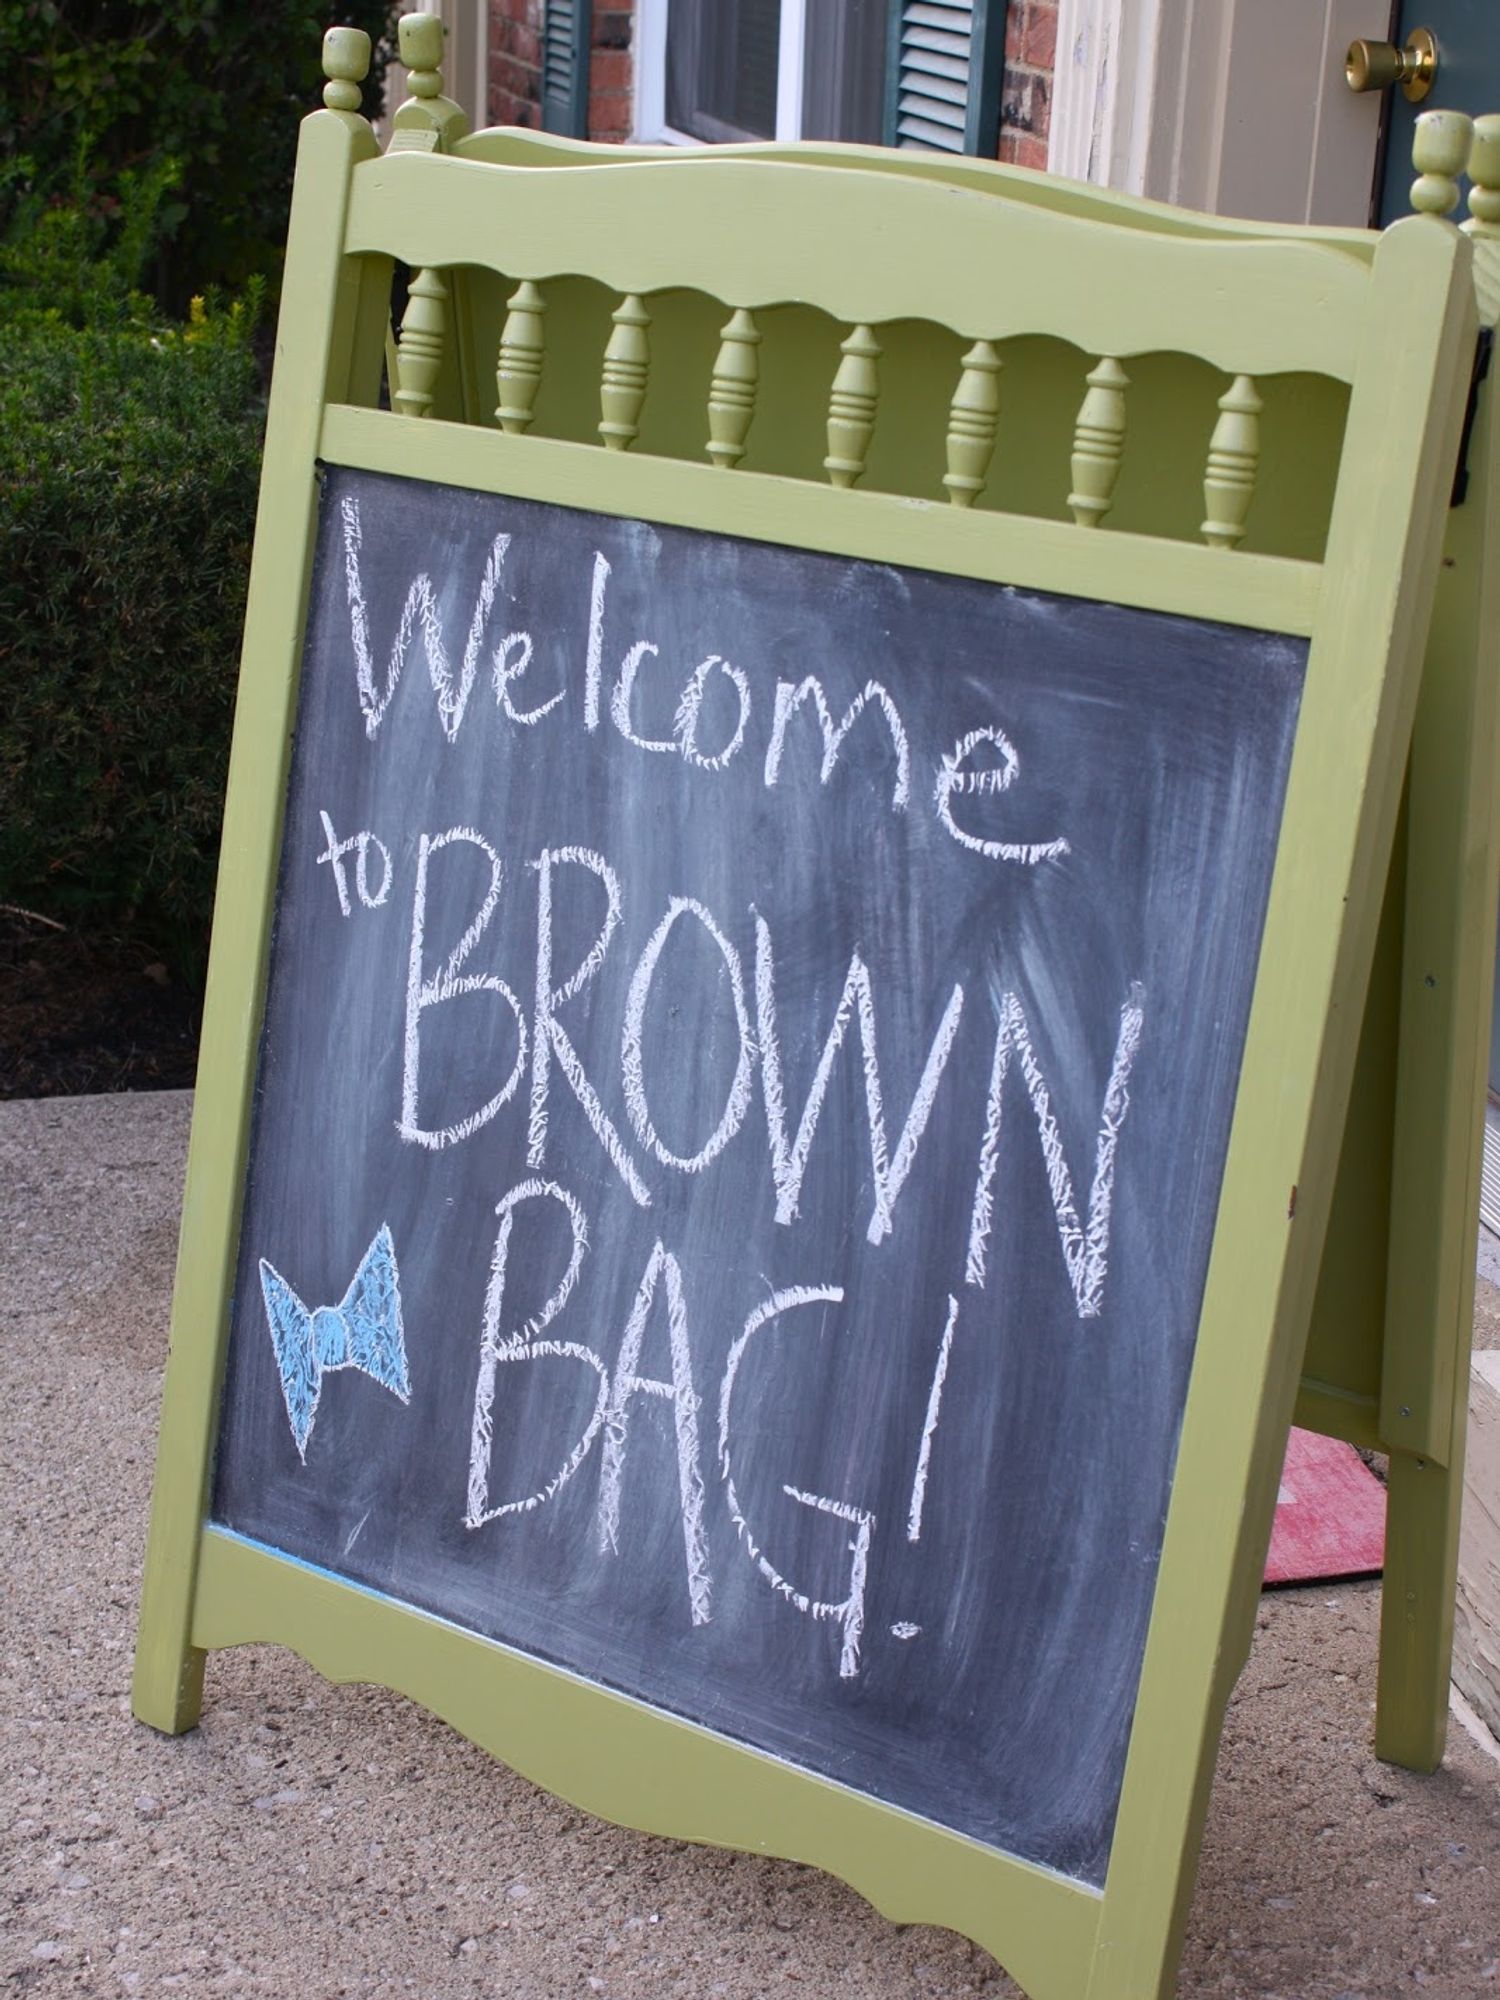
[472,110,1500,1772]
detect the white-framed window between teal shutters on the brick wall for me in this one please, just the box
[636,0,890,146]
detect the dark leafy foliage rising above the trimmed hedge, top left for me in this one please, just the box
[0,0,396,312]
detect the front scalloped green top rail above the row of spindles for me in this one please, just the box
[344,156,1384,382]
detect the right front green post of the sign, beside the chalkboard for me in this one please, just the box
[1088,220,1474,2000]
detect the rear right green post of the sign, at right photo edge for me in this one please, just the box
[1376,112,1500,1770]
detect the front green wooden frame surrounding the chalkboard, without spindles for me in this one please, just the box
[134,101,1474,2000]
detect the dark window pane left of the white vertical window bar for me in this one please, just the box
[666,0,782,140]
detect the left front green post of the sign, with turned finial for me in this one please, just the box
[132,28,378,1732]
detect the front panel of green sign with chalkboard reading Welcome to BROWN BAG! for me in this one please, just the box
[136,24,1496,2000]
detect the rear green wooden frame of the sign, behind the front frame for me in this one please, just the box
[454,125,1500,1770]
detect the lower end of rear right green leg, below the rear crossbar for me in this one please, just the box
[1376,1432,1464,1772]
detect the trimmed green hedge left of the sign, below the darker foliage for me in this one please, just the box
[0,288,262,980]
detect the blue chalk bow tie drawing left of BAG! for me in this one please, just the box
[260,1222,412,1464]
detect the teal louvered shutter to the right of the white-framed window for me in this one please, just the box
[886,0,1006,160]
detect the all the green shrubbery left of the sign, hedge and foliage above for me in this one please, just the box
[0,0,396,982]
